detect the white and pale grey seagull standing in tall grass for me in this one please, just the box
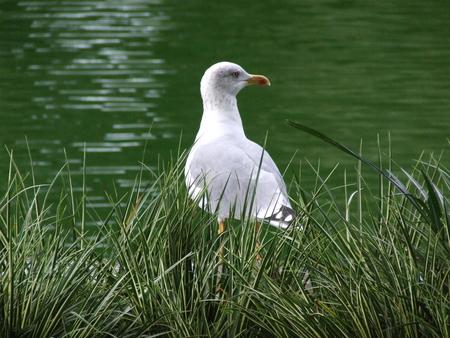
[185,62,295,234]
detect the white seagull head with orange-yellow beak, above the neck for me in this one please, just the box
[200,62,270,101]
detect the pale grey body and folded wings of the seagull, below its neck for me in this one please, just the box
[186,139,294,227]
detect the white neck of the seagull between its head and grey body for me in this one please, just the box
[197,94,245,137]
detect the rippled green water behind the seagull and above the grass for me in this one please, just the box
[0,0,450,215]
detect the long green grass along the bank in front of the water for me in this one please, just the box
[0,125,450,337]
